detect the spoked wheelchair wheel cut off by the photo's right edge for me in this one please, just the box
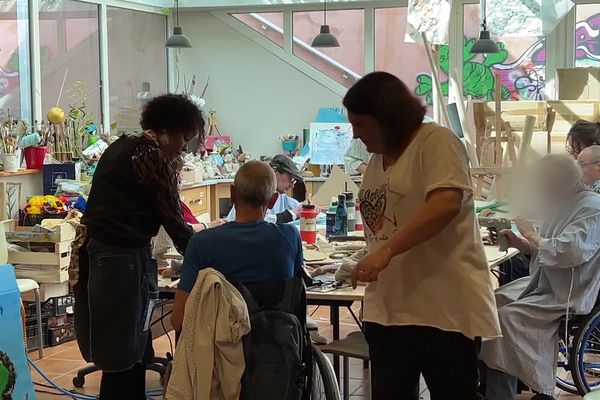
[571,307,600,395]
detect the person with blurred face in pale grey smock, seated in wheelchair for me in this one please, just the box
[480,155,600,400]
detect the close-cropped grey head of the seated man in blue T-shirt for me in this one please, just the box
[233,161,277,207]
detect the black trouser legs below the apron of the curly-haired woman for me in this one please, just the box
[100,363,146,400]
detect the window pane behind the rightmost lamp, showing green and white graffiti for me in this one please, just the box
[463,4,546,100]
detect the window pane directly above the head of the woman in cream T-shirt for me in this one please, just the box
[375,7,432,104]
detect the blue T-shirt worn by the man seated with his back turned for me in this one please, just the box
[178,221,303,293]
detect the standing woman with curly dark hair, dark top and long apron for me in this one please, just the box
[73,95,204,400]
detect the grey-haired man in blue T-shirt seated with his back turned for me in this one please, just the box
[171,161,303,332]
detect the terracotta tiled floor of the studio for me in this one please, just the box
[30,307,581,400]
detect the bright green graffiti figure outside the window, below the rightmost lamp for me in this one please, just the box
[415,38,510,104]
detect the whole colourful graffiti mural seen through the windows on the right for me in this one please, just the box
[415,13,600,104]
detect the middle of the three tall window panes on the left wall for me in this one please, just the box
[40,0,101,123]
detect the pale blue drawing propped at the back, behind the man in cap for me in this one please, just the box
[309,123,352,165]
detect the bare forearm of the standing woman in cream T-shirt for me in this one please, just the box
[385,198,460,257]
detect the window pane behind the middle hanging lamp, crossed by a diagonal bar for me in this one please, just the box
[293,10,365,87]
